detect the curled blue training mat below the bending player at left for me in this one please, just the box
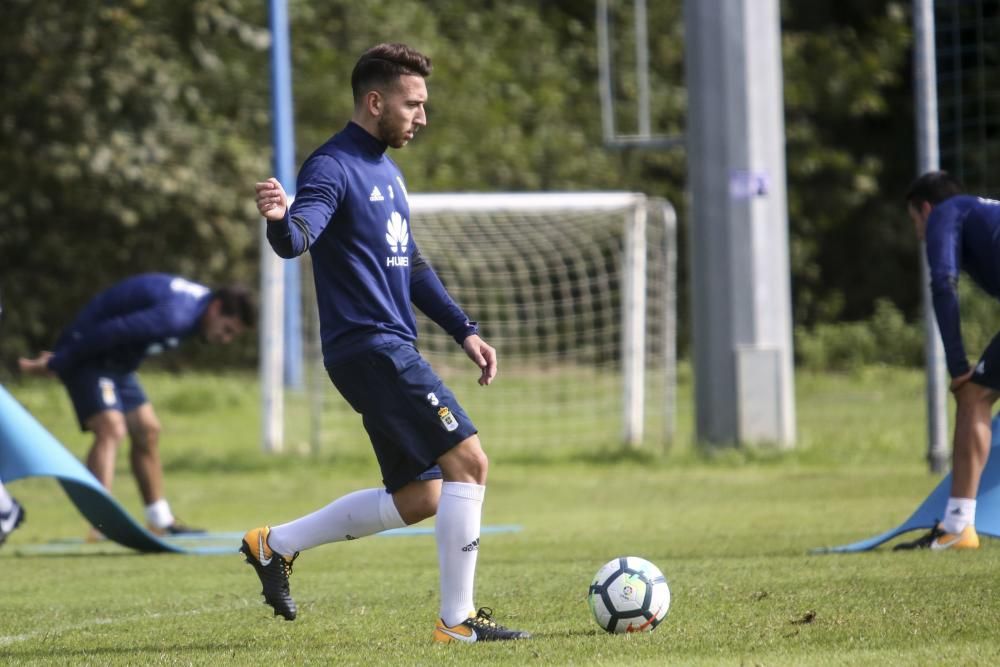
[0,386,194,553]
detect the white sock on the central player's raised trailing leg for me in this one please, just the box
[267,489,406,558]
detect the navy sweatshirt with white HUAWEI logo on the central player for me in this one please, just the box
[267,123,477,366]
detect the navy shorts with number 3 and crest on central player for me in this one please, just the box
[327,342,477,493]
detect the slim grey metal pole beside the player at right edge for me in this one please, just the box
[913,0,949,473]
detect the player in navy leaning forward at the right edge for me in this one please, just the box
[897,171,1000,550]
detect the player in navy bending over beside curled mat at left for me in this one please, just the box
[19,273,257,539]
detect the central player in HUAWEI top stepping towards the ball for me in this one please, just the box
[242,44,529,643]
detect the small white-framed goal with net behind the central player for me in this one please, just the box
[284,192,676,457]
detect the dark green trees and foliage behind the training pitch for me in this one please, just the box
[0,0,988,364]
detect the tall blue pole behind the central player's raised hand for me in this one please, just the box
[268,0,302,389]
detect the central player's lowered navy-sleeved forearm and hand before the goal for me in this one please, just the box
[410,242,497,386]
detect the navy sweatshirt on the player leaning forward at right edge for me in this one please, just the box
[925,195,1000,377]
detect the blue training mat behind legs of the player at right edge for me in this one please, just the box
[810,416,1000,554]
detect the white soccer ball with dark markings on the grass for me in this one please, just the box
[587,556,670,633]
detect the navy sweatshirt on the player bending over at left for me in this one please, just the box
[48,273,212,375]
